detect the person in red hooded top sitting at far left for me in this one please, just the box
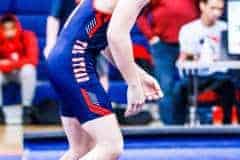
[0,14,38,123]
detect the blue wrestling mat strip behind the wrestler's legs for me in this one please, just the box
[24,127,240,160]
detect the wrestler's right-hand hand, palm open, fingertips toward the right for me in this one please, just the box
[141,73,164,101]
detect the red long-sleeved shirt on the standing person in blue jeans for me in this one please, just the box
[138,0,200,43]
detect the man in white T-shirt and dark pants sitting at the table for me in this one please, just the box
[173,0,235,124]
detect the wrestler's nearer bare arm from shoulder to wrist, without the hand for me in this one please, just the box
[107,0,147,85]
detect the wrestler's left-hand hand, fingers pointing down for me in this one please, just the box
[125,85,145,117]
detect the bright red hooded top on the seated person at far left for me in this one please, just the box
[0,16,39,72]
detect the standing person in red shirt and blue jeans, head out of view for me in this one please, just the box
[137,0,199,124]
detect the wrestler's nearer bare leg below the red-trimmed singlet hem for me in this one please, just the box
[79,114,123,160]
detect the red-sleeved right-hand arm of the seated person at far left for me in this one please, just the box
[16,31,39,69]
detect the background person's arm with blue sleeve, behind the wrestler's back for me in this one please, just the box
[44,0,62,57]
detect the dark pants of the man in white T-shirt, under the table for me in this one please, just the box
[173,74,236,124]
